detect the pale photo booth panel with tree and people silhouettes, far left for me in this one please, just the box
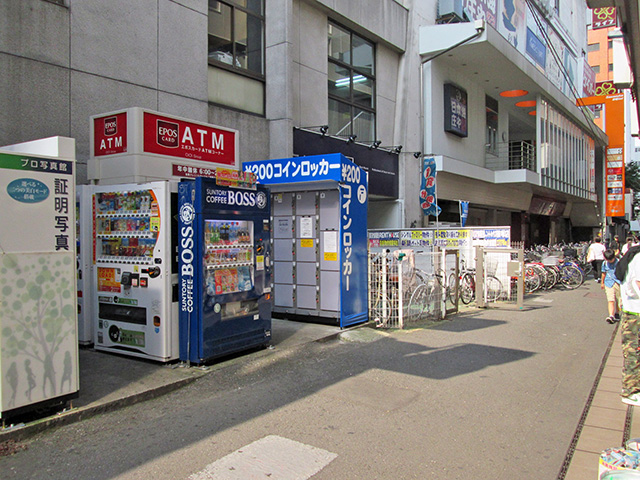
[0,153,79,416]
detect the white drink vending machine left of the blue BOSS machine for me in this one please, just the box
[93,181,179,362]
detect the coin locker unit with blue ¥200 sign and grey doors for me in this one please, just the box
[243,153,368,327]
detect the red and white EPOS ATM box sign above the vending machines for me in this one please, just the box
[87,107,239,185]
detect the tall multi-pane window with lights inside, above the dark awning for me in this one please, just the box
[328,22,376,142]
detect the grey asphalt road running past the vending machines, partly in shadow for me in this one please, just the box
[0,281,619,480]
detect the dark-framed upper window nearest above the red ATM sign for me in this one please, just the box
[208,0,264,77]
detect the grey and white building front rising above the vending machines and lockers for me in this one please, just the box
[0,0,606,243]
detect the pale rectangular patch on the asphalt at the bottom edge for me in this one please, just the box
[189,435,338,480]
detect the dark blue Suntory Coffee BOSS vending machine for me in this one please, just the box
[178,176,271,364]
